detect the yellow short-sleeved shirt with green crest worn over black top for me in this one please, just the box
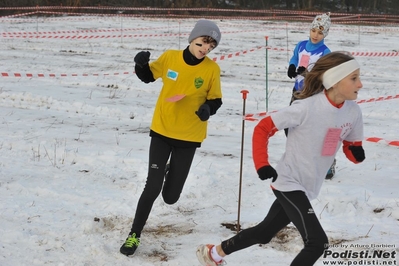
[150,50,222,142]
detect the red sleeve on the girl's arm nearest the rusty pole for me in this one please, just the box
[252,116,278,170]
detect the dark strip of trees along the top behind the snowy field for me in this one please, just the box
[0,0,399,15]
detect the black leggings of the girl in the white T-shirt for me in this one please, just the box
[222,190,328,266]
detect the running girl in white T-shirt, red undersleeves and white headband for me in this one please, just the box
[197,52,365,266]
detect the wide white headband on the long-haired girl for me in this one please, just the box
[323,59,360,89]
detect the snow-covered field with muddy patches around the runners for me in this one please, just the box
[0,13,399,266]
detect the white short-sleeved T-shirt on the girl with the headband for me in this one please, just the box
[254,92,363,200]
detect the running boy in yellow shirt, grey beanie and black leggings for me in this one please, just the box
[120,19,222,256]
